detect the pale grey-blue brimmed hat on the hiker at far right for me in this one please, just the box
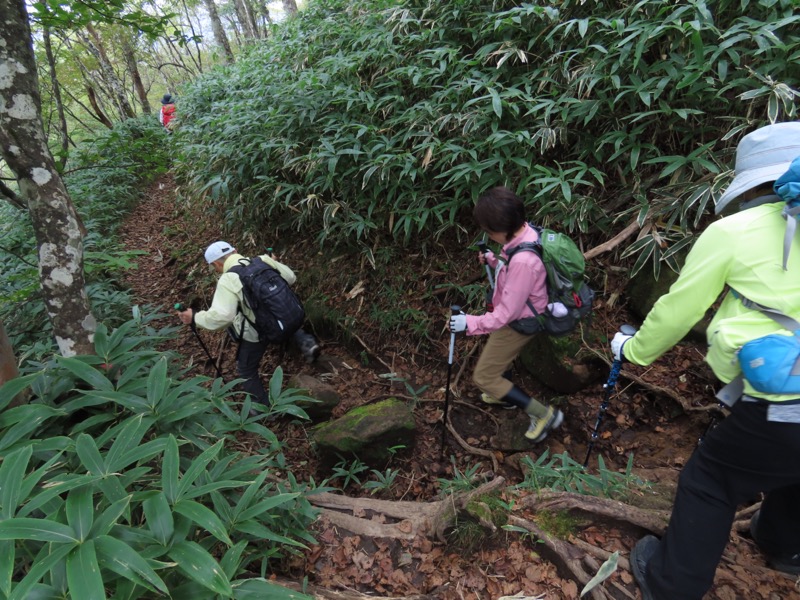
[714,121,800,214]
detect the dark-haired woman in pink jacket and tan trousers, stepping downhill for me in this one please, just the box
[450,187,564,442]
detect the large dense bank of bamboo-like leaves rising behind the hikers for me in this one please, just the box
[175,0,800,271]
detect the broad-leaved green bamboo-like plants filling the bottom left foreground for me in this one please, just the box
[0,319,315,599]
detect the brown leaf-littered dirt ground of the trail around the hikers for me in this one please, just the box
[115,171,800,600]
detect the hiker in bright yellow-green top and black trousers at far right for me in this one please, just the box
[611,122,800,600]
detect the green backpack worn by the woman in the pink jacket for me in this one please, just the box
[507,225,594,336]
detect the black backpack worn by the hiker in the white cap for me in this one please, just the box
[230,256,306,344]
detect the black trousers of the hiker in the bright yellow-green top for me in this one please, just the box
[646,401,800,600]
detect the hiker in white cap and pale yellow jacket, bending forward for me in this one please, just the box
[178,241,320,405]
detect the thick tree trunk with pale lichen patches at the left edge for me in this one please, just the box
[0,0,96,356]
